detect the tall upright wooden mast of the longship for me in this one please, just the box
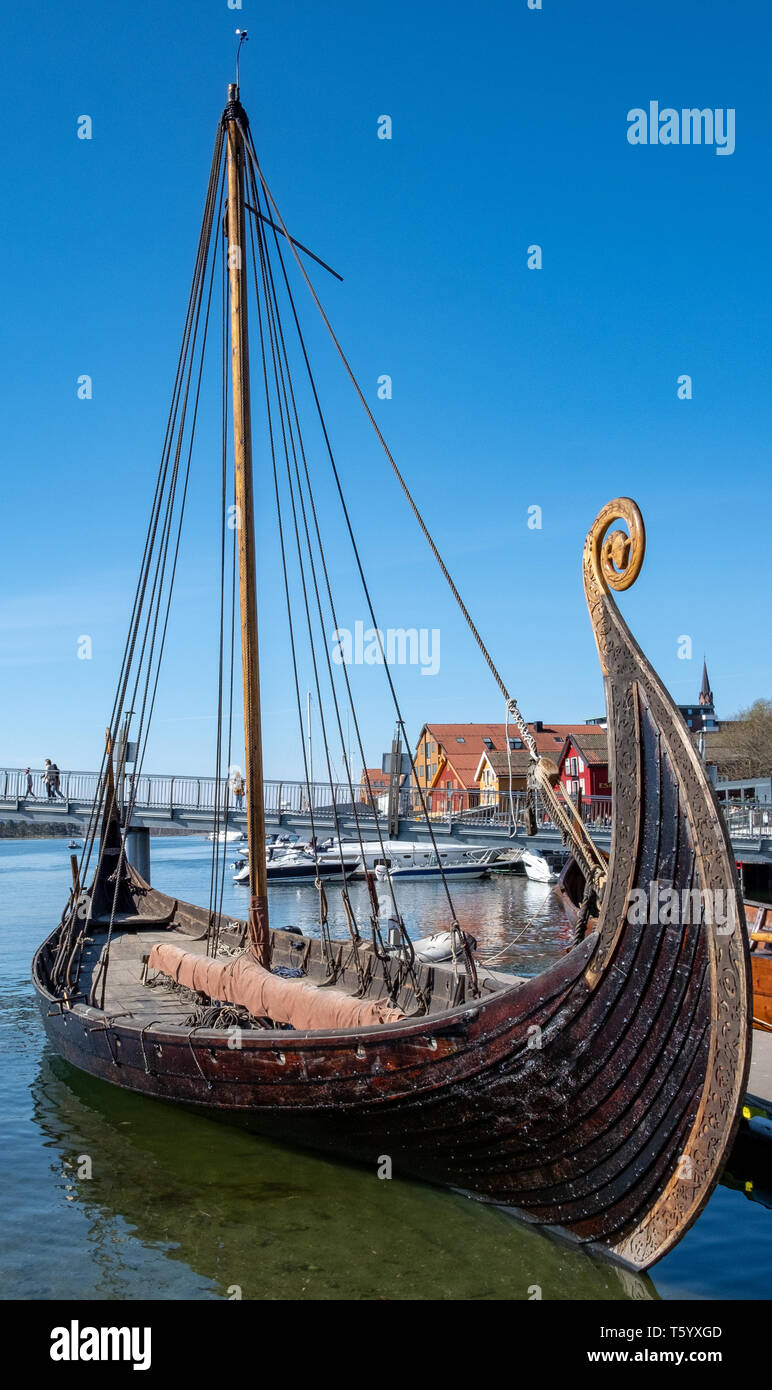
[225,85,270,969]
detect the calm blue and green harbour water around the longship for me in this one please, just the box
[0,837,772,1300]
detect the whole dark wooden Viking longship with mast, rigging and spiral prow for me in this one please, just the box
[32,73,750,1269]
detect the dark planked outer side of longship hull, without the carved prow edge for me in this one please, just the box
[28,884,707,1265]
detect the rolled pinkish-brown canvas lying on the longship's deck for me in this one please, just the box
[147,941,405,1030]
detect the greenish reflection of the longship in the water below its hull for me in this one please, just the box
[32,1051,657,1301]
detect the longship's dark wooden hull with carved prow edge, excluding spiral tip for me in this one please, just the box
[33,500,750,1269]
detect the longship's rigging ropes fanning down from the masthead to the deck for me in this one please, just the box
[67,103,584,1005]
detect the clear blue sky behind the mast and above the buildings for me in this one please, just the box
[0,0,772,777]
